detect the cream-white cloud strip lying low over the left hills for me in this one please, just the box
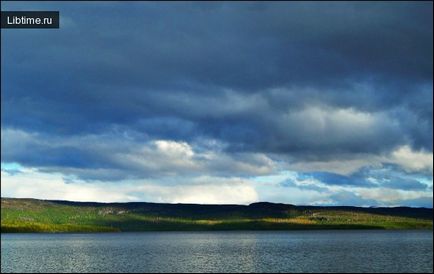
[1,168,258,204]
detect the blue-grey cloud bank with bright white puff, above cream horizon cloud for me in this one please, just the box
[1,128,276,181]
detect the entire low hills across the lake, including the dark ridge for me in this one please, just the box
[1,198,433,232]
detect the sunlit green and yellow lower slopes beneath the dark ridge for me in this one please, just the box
[1,199,432,232]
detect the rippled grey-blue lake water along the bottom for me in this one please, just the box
[1,230,433,272]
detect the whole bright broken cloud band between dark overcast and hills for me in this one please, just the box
[1,127,432,205]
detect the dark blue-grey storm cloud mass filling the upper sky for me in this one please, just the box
[2,2,433,176]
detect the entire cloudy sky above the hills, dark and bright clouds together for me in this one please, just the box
[1,2,433,207]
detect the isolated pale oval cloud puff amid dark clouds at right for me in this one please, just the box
[278,105,400,149]
